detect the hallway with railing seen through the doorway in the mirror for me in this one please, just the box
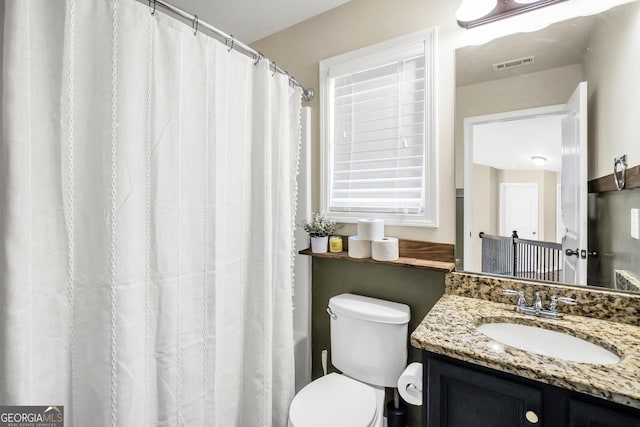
[464,108,564,280]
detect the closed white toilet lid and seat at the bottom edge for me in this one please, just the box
[289,373,378,427]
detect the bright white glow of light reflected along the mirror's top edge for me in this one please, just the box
[456,0,636,48]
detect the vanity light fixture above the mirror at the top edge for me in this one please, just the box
[456,0,567,29]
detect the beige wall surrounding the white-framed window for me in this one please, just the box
[252,0,463,243]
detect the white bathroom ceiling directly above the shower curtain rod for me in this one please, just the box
[167,0,349,44]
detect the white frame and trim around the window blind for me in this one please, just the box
[320,28,439,228]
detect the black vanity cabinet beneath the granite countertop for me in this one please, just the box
[422,351,640,427]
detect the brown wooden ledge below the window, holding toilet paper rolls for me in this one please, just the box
[299,236,456,273]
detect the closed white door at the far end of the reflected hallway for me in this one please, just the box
[500,183,538,240]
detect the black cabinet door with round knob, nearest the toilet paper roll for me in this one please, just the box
[425,358,543,427]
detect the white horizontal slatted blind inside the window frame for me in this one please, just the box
[330,55,425,213]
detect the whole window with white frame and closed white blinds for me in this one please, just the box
[320,30,438,227]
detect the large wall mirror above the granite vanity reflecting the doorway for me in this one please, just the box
[455,0,640,292]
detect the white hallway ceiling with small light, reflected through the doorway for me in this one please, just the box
[473,115,562,172]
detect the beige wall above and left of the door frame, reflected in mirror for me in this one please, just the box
[455,64,582,188]
